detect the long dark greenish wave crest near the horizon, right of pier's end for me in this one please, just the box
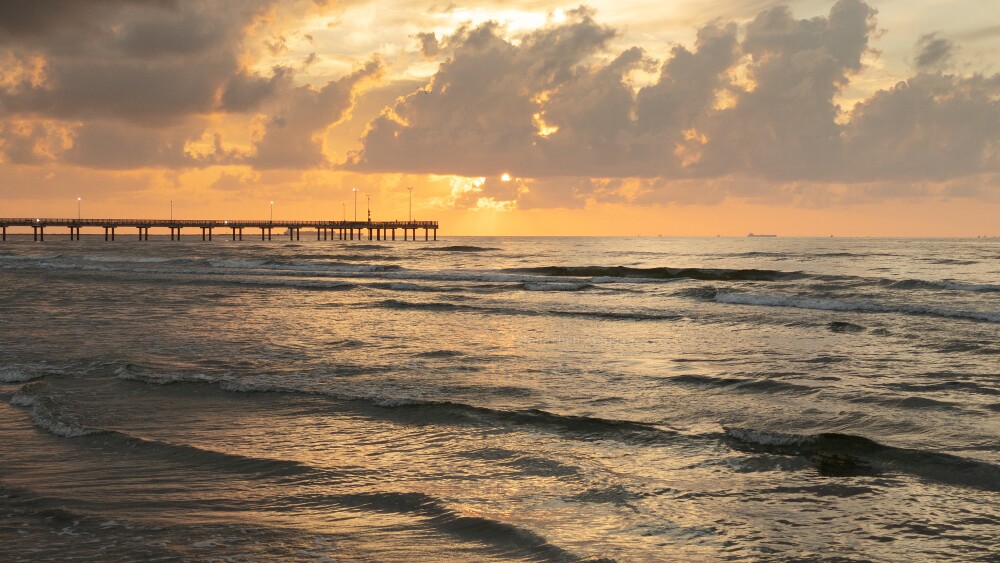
[501,266,806,281]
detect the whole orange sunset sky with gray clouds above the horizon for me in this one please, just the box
[0,0,1000,236]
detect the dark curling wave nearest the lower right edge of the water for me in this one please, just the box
[723,427,1000,492]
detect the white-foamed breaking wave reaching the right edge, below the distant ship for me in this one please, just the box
[714,291,1000,323]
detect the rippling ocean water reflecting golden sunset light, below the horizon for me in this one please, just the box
[0,233,1000,561]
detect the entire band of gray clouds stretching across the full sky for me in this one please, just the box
[0,0,1000,205]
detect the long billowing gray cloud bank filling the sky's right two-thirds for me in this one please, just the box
[344,0,1000,209]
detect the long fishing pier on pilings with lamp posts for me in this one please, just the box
[0,218,438,241]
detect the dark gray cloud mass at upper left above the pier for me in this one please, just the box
[0,0,381,169]
